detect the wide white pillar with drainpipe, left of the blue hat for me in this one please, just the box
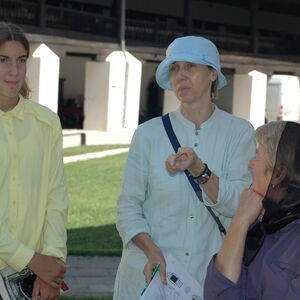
[84,51,142,132]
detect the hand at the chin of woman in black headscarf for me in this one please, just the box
[234,188,264,226]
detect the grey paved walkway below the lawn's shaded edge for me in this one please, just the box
[64,256,120,297]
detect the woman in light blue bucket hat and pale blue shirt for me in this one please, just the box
[114,36,255,300]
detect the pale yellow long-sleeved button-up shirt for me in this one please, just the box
[0,97,68,271]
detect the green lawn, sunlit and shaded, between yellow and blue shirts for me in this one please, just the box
[65,153,127,255]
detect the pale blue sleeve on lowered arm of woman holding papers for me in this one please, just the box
[116,127,150,247]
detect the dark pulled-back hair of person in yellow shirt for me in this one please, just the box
[0,22,30,98]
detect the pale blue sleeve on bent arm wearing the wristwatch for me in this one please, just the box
[203,122,255,218]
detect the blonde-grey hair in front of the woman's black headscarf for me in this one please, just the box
[255,121,286,172]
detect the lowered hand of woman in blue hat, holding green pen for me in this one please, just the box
[144,247,167,284]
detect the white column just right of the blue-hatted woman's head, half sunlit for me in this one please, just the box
[232,70,267,128]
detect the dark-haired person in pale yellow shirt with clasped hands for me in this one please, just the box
[0,23,68,300]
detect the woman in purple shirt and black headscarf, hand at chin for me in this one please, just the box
[204,121,300,300]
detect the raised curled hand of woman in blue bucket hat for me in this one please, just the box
[166,147,205,176]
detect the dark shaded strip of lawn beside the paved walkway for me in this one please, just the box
[68,224,122,256]
